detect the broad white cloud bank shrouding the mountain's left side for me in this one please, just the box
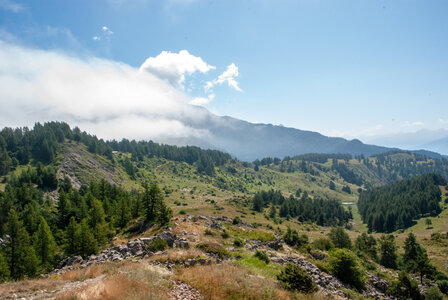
[0,41,210,142]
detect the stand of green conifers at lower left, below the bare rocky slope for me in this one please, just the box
[0,178,172,281]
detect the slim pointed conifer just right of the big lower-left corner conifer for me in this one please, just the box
[34,217,57,270]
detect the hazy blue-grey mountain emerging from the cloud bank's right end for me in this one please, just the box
[164,108,392,161]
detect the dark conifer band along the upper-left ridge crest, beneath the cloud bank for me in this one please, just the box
[0,122,232,176]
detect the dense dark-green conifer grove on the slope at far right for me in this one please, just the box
[358,174,445,232]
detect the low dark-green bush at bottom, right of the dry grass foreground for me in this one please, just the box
[277,264,317,293]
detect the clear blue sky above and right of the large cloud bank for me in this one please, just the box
[0,0,448,138]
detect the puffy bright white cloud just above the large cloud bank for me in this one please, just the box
[140,50,215,88]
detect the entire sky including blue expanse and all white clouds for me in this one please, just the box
[0,0,448,140]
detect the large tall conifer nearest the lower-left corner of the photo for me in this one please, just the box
[6,209,37,279]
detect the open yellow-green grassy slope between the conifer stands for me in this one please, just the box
[43,143,448,267]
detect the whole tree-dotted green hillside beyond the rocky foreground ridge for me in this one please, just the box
[0,122,448,299]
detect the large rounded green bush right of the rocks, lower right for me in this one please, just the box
[328,249,366,291]
